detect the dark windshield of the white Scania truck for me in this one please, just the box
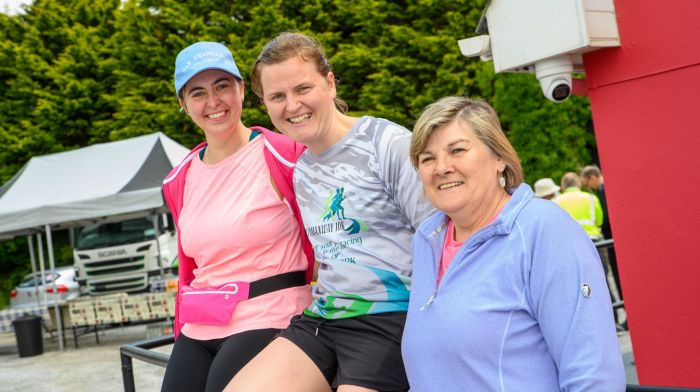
[75,218,156,250]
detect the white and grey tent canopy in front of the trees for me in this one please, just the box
[0,132,188,238]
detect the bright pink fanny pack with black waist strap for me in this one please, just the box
[177,271,306,325]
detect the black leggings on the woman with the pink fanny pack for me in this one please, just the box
[161,329,280,392]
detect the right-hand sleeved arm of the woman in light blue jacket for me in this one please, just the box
[526,209,625,392]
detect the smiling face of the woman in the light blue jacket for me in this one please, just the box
[418,120,505,220]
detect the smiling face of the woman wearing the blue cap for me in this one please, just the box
[180,69,244,139]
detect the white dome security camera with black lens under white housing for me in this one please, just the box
[535,55,574,102]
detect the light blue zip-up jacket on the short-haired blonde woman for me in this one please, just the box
[402,184,625,392]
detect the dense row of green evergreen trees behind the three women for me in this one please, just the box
[0,0,594,182]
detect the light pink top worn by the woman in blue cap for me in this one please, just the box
[179,137,311,340]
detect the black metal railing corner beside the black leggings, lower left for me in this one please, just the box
[119,334,175,392]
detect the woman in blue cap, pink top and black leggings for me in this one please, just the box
[162,42,313,391]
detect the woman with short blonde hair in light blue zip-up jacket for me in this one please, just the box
[402,97,625,392]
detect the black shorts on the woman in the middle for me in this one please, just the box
[279,312,408,392]
